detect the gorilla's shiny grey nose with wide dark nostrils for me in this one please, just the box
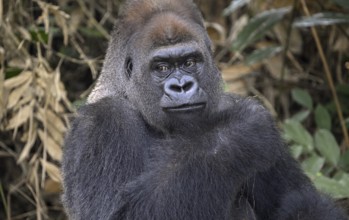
[164,76,199,99]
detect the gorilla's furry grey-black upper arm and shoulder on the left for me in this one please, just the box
[62,98,147,219]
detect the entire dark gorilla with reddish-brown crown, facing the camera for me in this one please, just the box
[62,0,346,220]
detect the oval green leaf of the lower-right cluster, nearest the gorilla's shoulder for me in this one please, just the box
[283,119,314,151]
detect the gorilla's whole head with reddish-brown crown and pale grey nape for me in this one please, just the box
[89,0,221,130]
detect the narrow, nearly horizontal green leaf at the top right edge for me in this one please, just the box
[293,12,349,27]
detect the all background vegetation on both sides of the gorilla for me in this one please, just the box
[0,0,349,219]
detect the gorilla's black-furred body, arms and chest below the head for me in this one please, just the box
[63,95,346,220]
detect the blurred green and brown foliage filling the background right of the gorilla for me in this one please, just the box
[223,0,349,198]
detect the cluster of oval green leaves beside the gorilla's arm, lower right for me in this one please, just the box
[283,88,349,198]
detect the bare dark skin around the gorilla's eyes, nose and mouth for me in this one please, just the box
[150,47,207,112]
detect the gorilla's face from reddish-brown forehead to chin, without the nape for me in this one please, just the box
[126,14,221,130]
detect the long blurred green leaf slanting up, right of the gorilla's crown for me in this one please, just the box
[232,7,290,51]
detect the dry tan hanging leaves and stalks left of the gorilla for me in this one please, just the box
[0,0,118,219]
